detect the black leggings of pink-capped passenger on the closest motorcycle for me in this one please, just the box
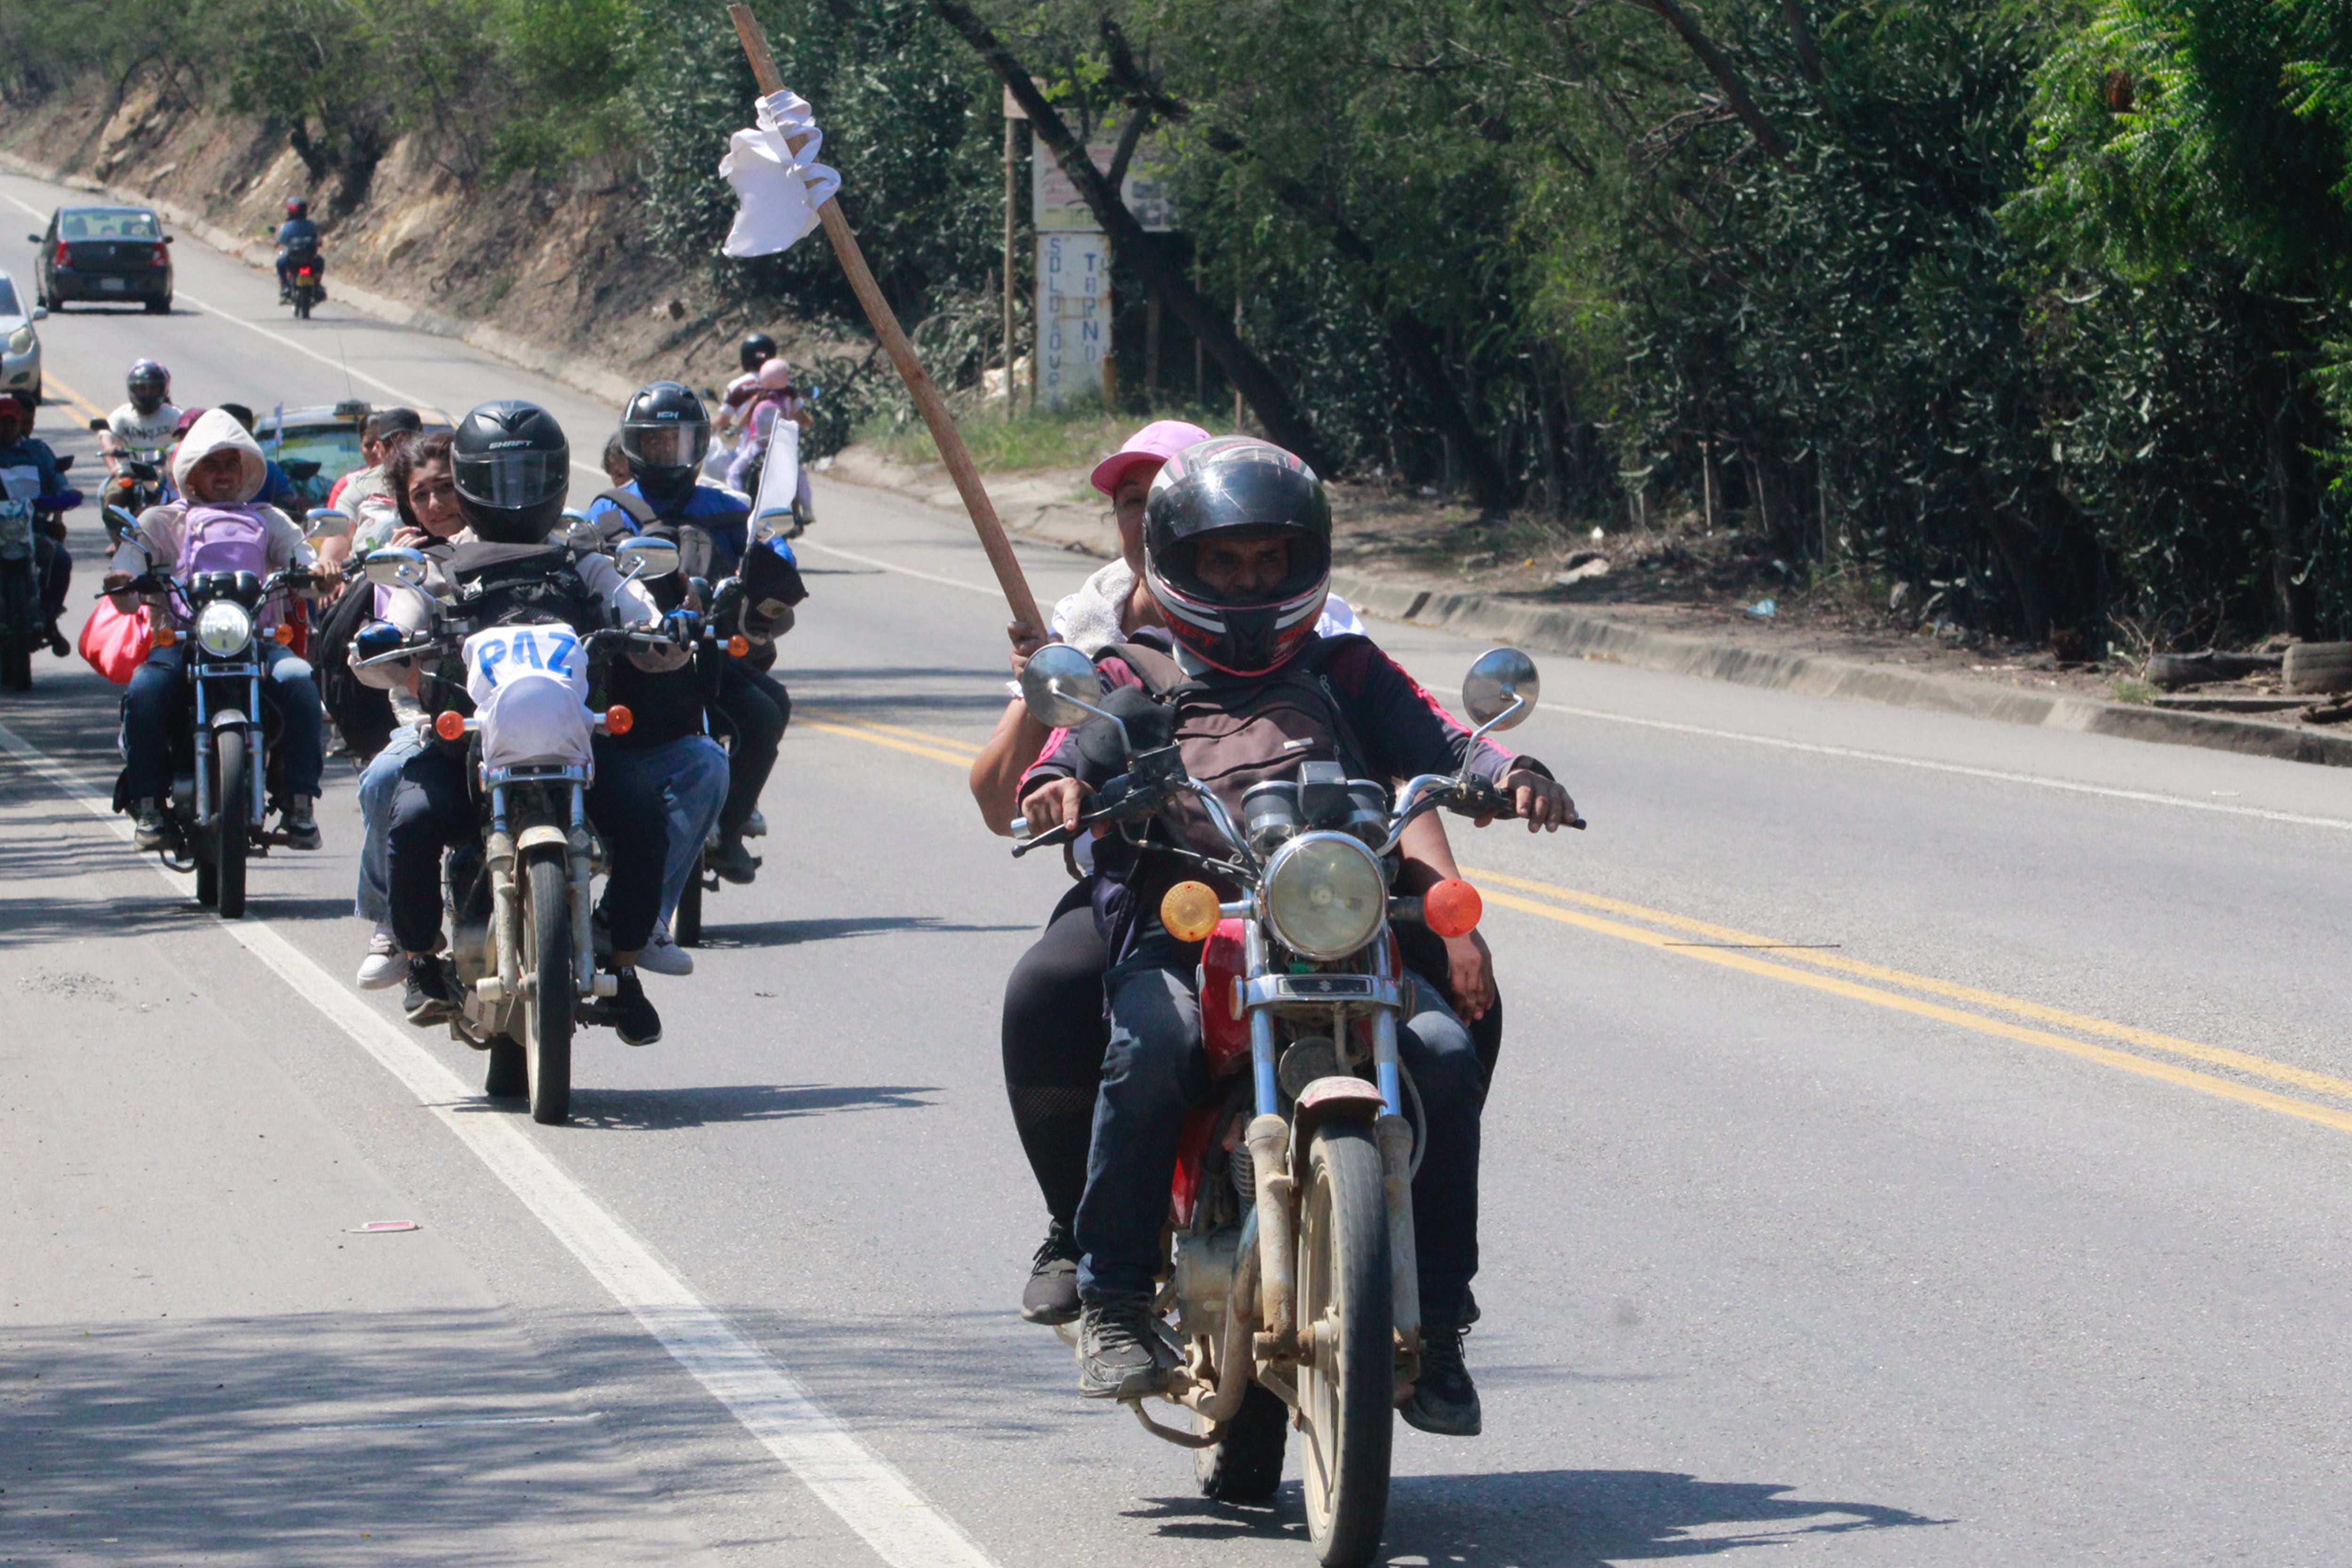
[1002,882,1503,1227]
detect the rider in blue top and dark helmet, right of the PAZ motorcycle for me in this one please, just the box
[588,381,807,891]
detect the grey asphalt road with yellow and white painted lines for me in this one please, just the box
[0,166,2352,1568]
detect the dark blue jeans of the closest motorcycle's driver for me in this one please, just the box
[1075,931,1486,1326]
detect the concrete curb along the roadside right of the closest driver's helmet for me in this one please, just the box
[1331,571,2352,766]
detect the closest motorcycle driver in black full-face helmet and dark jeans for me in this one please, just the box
[1021,437,1573,1436]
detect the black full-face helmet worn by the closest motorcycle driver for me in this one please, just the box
[1143,435,1331,675]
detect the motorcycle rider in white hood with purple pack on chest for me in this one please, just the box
[103,409,325,849]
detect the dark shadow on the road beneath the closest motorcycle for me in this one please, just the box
[1134,1469,1952,1568]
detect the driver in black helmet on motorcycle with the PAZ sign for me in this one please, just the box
[367,402,687,1046]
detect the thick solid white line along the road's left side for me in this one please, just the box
[0,724,995,1568]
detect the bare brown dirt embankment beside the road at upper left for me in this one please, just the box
[0,80,790,402]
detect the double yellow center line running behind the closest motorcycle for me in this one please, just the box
[804,710,2352,1133]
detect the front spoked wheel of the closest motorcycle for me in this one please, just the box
[1298,1122,1397,1568]
